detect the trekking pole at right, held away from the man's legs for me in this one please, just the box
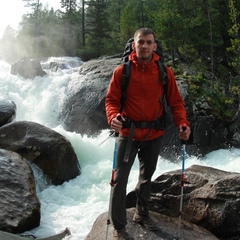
[177,124,187,240]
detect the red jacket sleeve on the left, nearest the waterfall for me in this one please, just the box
[105,65,122,125]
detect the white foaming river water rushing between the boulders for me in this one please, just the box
[0,57,240,240]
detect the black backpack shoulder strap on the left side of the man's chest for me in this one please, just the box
[119,61,132,113]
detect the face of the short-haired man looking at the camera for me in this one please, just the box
[132,34,157,62]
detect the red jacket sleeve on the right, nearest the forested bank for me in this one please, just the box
[167,67,189,127]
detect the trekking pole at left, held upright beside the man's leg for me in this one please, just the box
[106,115,121,240]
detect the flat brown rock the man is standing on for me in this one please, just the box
[85,208,218,240]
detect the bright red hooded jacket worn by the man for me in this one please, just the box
[105,51,188,141]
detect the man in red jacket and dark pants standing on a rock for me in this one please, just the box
[105,28,190,239]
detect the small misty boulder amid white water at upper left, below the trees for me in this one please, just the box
[10,58,47,79]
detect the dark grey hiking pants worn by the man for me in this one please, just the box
[111,135,162,229]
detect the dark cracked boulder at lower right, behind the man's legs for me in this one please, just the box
[127,165,240,240]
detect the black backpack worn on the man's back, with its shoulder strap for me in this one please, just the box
[119,38,167,113]
